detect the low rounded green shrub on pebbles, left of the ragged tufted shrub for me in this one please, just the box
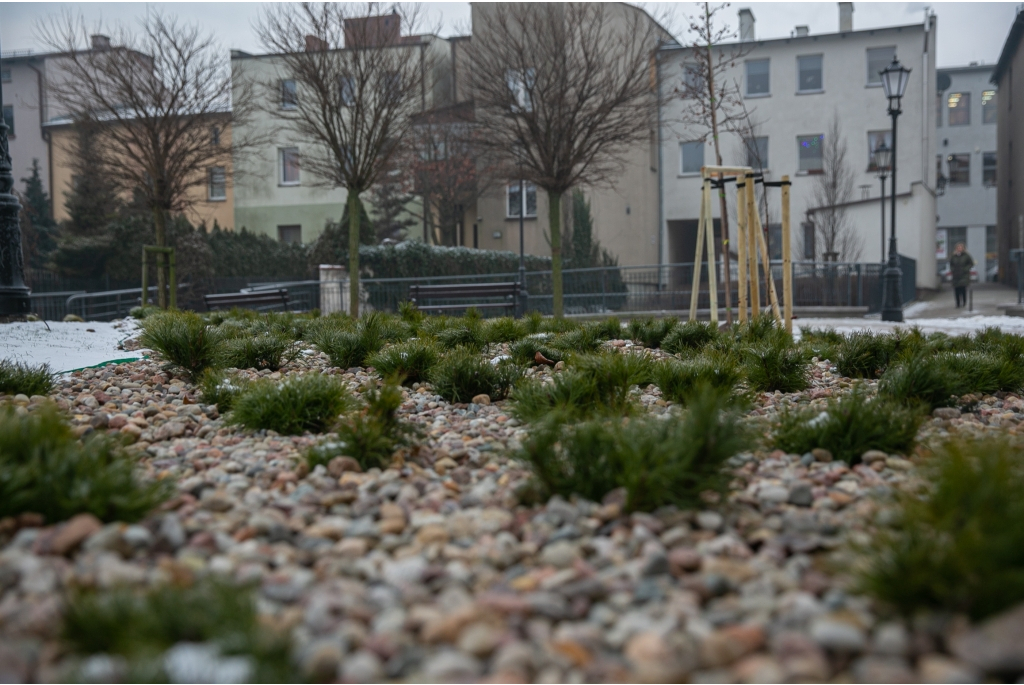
[230,373,352,435]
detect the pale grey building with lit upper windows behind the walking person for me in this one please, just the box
[936,63,998,281]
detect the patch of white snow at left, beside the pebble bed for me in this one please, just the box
[0,319,142,372]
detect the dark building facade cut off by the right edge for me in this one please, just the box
[990,9,1024,284]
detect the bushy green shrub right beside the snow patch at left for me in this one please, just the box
[139,310,223,380]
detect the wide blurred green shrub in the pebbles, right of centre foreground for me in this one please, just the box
[517,390,750,511]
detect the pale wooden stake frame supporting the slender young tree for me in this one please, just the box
[689,166,793,334]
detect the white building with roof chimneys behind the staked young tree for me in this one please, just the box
[659,3,938,288]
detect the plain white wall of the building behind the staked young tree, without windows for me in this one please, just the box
[662,19,937,288]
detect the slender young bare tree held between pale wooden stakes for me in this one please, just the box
[676,2,749,324]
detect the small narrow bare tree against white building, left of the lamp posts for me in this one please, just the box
[811,112,861,261]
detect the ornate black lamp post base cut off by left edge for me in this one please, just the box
[0,45,31,320]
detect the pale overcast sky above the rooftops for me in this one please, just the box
[0,2,1015,67]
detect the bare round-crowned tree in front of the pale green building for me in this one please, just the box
[256,3,437,315]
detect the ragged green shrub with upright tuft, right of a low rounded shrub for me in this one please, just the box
[306,379,416,469]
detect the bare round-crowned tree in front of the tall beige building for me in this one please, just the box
[470,3,669,316]
